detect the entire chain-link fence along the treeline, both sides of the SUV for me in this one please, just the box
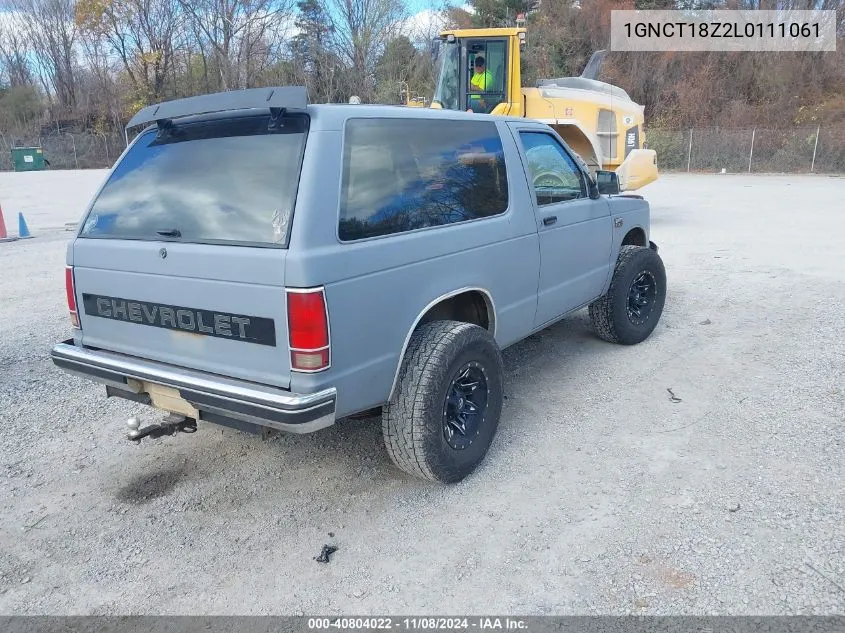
[0,126,845,173]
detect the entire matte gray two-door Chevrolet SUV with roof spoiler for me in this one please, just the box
[52,86,666,484]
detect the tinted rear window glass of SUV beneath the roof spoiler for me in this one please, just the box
[80,115,308,247]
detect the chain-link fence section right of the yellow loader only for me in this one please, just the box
[646,125,845,173]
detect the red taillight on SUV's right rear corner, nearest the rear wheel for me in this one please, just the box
[287,289,329,371]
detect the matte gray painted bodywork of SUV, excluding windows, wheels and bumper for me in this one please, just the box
[61,97,649,424]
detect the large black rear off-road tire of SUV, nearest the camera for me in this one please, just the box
[382,321,504,484]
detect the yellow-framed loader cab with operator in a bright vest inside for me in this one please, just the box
[432,28,525,116]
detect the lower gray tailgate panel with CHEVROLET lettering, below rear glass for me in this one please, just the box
[73,240,290,388]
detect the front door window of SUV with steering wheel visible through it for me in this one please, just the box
[519,132,587,206]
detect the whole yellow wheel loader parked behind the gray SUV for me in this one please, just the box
[426,28,657,191]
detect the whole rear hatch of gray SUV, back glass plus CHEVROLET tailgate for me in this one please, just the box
[71,114,307,388]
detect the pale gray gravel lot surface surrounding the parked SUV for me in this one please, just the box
[0,172,845,615]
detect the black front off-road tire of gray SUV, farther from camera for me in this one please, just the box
[590,245,666,345]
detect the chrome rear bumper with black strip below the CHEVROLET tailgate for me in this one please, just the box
[50,339,337,433]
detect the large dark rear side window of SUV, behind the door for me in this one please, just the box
[338,118,508,241]
